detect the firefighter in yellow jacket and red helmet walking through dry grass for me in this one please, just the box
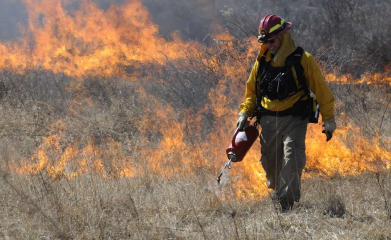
[237,14,336,212]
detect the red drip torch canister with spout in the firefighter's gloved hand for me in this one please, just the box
[217,122,259,184]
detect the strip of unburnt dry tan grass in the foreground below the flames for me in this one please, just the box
[0,170,391,239]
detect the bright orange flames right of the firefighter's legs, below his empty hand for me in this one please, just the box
[306,122,391,176]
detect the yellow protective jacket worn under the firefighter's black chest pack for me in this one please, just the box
[239,31,334,121]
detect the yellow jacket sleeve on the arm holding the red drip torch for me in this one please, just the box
[239,61,258,116]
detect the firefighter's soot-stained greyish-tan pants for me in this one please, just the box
[260,115,308,202]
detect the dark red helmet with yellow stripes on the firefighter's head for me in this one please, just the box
[258,14,292,43]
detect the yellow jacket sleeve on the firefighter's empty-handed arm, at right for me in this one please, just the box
[301,52,334,122]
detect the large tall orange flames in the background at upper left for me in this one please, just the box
[0,0,196,77]
